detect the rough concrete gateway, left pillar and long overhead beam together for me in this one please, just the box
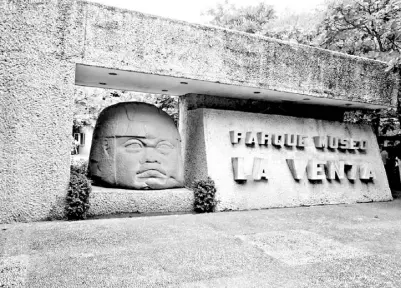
[0,0,398,222]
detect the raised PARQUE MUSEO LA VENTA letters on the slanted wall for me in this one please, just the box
[229,130,375,182]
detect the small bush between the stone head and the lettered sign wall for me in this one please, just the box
[192,177,218,213]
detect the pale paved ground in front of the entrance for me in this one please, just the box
[0,200,401,288]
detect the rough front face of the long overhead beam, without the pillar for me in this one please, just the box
[77,3,399,108]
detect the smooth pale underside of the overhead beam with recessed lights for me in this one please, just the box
[75,64,386,109]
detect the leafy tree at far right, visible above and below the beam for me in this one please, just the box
[320,0,401,133]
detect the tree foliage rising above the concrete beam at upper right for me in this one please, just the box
[206,0,401,70]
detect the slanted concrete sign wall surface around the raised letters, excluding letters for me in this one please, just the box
[185,109,392,211]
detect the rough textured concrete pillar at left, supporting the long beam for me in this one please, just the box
[0,1,83,222]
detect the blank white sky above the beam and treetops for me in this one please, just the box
[85,0,324,24]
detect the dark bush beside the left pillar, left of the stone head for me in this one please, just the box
[66,163,92,220]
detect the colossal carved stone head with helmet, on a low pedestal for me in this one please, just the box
[89,102,184,189]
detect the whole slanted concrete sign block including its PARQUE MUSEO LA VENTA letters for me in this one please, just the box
[185,109,392,210]
